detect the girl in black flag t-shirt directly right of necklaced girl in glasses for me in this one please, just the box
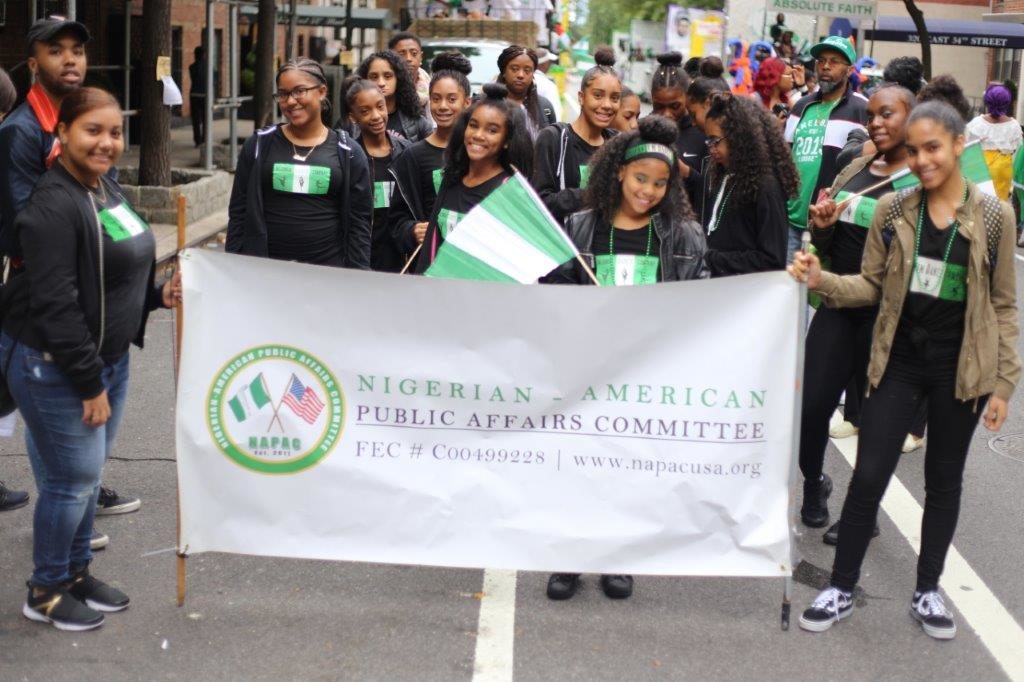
[341,76,409,272]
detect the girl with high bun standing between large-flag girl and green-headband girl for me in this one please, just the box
[530,48,623,222]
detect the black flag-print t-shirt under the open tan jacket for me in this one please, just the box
[893,211,971,361]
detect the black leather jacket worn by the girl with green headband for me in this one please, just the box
[546,209,710,284]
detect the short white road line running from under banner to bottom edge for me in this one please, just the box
[473,568,516,682]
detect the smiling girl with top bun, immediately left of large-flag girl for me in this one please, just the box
[388,52,473,260]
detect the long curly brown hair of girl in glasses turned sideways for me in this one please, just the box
[707,94,800,201]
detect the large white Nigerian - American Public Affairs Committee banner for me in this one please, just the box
[177,250,799,577]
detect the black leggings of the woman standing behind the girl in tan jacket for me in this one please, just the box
[800,306,876,480]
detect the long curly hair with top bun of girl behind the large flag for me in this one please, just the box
[443,83,534,186]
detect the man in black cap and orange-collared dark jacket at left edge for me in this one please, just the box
[0,16,140,520]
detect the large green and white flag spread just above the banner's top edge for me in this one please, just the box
[426,173,579,284]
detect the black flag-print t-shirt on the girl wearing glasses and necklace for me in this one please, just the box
[260,128,344,266]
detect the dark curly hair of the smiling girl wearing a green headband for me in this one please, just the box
[584,116,694,224]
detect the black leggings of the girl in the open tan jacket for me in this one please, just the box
[831,348,987,592]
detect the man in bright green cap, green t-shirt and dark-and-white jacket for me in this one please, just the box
[785,36,867,262]
